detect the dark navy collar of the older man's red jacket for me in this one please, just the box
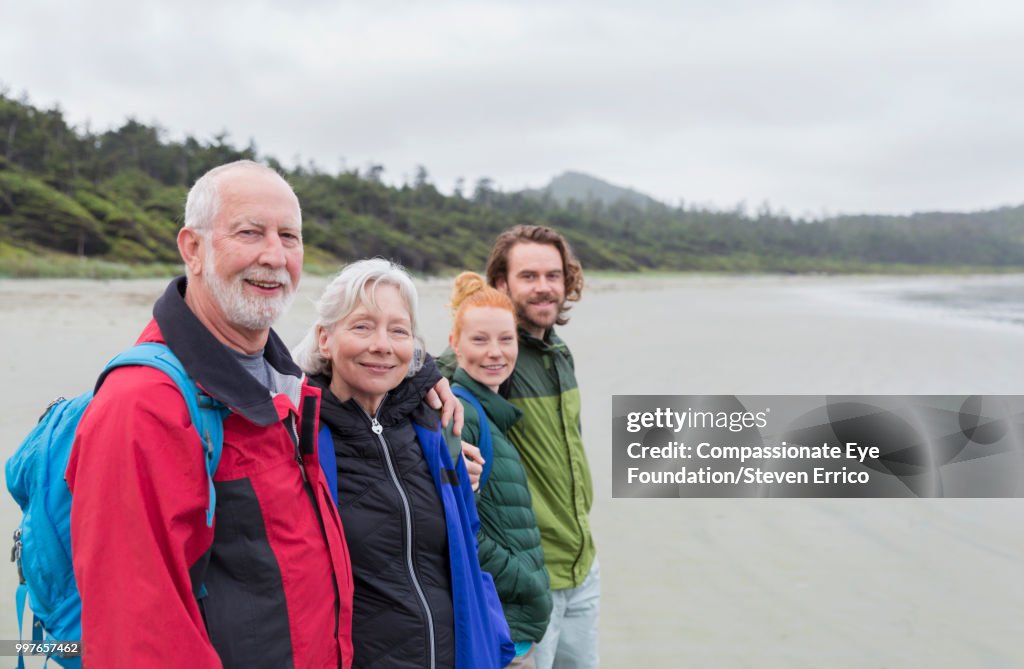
[153,277,302,427]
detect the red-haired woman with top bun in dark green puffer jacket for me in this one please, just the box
[449,271,551,669]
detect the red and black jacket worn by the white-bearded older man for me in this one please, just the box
[68,280,352,669]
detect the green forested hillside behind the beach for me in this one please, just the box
[0,92,1024,278]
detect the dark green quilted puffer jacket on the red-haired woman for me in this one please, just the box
[453,369,551,642]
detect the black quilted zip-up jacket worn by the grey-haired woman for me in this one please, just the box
[310,363,455,669]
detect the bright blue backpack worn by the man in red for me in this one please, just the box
[6,342,228,669]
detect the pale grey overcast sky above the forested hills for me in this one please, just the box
[0,0,1024,216]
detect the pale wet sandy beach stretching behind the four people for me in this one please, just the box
[0,277,1024,669]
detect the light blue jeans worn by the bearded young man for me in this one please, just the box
[537,557,601,669]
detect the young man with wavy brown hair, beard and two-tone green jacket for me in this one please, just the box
[439,225,601,669]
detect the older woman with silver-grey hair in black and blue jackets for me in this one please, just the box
[295,259,513,669]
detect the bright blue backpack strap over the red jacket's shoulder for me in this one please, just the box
[95,341,230,528]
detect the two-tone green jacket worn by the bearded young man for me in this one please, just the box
[437,329,596,590]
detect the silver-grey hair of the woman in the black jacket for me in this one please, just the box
[292,258,426,376]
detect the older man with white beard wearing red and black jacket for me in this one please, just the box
[67,161,460,669]
